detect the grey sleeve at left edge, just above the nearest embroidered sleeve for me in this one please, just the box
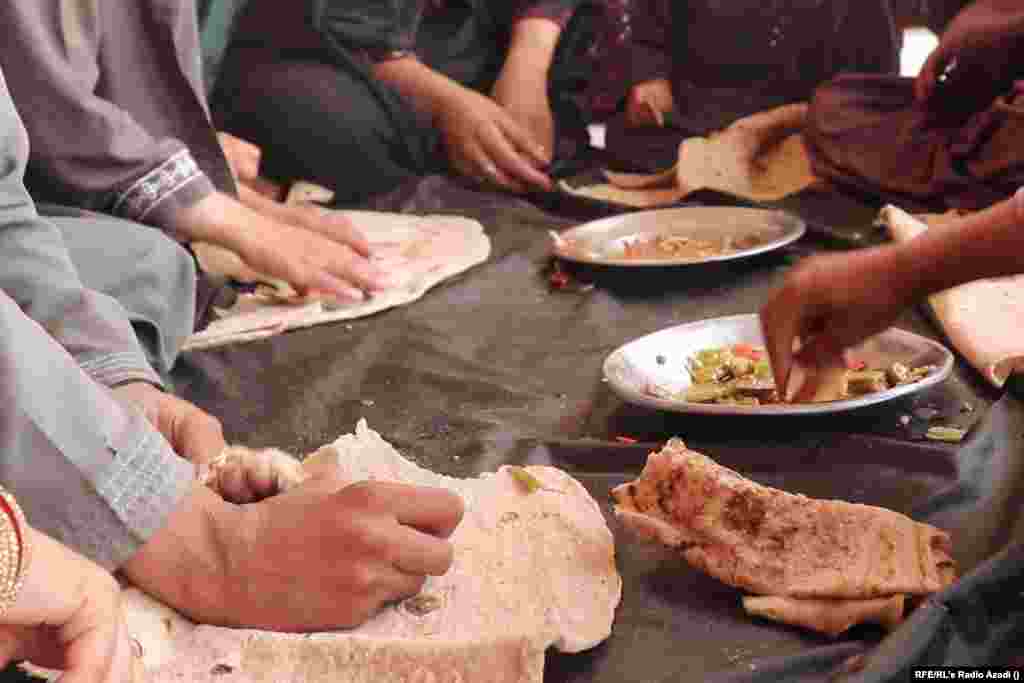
[0,74,161,386]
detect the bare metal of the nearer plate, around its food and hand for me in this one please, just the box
[604,314,953,415]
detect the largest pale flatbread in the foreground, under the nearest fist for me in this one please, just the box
[116,420,622,683]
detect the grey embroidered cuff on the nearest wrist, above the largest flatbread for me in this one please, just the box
[92,411,196,568]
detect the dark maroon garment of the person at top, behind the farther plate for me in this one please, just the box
[606,0,900,170]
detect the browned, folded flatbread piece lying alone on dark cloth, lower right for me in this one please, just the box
[611,438,955,636]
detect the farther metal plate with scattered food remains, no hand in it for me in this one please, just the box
[551,207,806,266]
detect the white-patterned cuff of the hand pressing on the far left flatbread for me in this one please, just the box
[111,150,214,237]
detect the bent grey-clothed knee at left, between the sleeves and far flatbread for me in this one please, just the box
[41,207,196,378]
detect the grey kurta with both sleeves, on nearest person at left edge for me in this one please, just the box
[0,69,194,568]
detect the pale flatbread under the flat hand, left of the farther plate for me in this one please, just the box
[182,211,490,351]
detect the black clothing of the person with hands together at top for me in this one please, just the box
[212,0,601,203]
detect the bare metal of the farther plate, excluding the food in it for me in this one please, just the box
[552,207,806,267]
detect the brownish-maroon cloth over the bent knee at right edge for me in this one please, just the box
[806,75,1024,210]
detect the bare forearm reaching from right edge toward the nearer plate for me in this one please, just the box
[894,194,1024,298]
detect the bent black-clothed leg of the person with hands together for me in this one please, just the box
[213,53,437,202]
